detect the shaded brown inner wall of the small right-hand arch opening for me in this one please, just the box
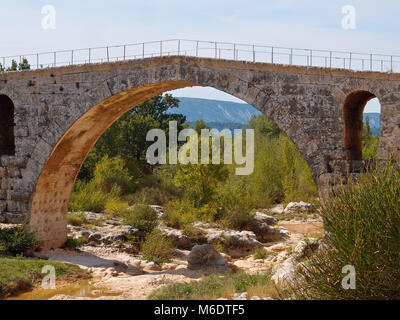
[343,90,376,161]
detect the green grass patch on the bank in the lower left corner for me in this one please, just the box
[0,257,89,299]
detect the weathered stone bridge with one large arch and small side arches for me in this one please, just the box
[0,56,400,248]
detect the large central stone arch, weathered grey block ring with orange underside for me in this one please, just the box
[24,58,322,248]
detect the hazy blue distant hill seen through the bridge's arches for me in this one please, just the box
[170,97,380,135]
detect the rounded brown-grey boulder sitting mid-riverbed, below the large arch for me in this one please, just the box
[188,244,227,270]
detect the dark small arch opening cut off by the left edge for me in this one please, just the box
[0,94,15,156]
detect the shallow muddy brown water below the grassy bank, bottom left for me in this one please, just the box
[6,281,122,300]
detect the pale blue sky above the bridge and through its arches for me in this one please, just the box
[0,0,400,112]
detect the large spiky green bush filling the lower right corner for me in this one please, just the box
[287,164,400,300]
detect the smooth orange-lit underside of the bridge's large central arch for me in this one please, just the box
[29,81,316,249]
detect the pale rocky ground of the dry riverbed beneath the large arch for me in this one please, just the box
[26,203,323,300]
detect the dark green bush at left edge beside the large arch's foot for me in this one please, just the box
[0,224,40,256]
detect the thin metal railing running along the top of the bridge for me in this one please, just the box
[0,39,400,72]
